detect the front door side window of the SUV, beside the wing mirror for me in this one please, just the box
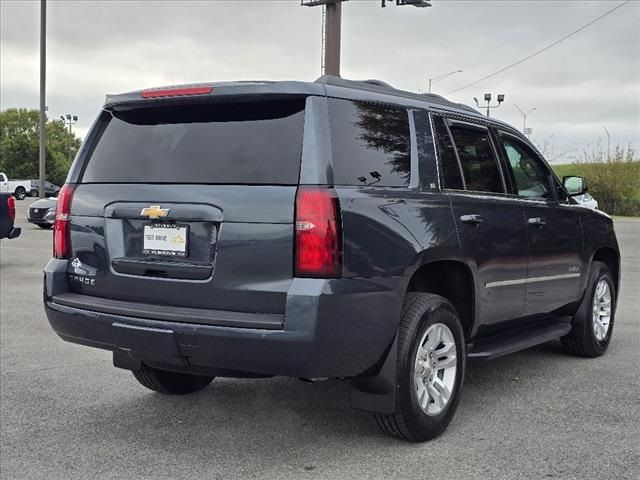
[501,135,553,198]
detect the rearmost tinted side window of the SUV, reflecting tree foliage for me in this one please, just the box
[329,99,411,187]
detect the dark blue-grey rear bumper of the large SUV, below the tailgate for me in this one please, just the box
[45,260,403,378]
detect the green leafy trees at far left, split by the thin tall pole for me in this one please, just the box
[0,108,81,185]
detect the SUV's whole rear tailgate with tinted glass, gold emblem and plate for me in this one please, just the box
[69,97,305,313]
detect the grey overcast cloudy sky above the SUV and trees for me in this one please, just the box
[0,0,640,163]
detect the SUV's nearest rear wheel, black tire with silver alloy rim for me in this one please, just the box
[375,293,466,442]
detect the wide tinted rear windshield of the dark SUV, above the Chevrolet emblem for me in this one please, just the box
[82,99,304,185]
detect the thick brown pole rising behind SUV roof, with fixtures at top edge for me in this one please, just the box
[300,0,431,77]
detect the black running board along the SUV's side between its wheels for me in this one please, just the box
[467,317,571,360]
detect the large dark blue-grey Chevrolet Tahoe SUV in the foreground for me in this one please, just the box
[44,77,620,441]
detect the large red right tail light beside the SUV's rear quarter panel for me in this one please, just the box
[295,187,342,278]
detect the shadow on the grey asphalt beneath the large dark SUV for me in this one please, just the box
[76,343,566,461]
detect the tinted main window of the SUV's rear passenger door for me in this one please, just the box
[450,123,504,193]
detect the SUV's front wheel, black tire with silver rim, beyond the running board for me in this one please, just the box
[560,262,616,358]
